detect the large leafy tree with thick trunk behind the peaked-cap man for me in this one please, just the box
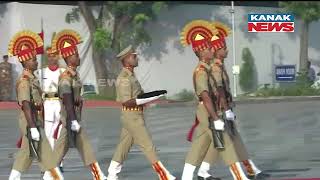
[66,1,167,97]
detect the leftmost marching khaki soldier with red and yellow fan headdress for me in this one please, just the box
[9,31,63,180]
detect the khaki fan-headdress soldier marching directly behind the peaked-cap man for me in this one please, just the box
[51,29,106,180]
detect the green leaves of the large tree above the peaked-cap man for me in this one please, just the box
[66,1,168,50]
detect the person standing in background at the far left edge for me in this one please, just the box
[0,55,12,101]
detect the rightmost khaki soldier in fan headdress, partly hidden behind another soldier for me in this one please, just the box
[199,21,269,179]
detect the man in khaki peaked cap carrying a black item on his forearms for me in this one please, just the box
[108,46,176,180]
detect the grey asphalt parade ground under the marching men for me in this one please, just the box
[0,101,320,180]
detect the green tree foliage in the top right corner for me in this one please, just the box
[280,1,320,23]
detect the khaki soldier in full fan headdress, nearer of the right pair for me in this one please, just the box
[181,20,242,180]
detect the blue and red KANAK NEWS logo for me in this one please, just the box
[248,14,294,32]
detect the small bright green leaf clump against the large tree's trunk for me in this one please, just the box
[93,28,111,51]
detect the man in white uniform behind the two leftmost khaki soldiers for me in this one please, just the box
[38,47,65,172]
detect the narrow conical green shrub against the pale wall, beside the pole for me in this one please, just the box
[239,48,257,92]
